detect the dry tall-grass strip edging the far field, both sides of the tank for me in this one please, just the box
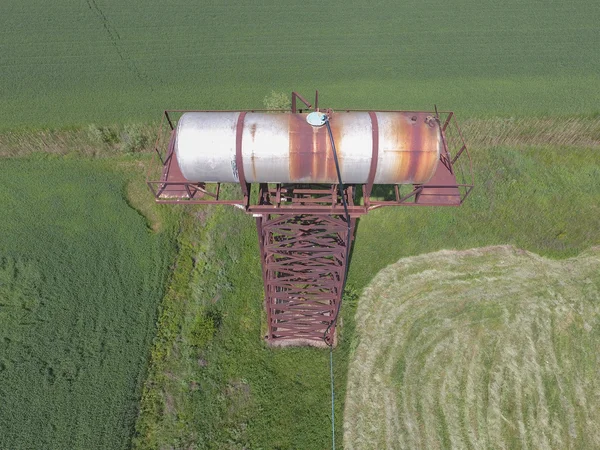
[0,116,600,157]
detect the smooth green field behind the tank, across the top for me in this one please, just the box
[0,0,600,129]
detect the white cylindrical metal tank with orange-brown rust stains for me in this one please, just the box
[175,112,443,184]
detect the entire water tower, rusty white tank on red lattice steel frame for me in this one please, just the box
[148,92,473,346]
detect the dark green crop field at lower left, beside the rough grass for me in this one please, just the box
[0,156,172,449]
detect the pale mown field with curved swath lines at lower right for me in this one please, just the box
[344,246,600,449]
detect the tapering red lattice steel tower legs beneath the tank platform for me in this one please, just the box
[256,214,356,345]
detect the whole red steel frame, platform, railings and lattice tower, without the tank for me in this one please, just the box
[147,97,474,346]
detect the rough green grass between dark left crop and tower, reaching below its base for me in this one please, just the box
[134,197,356,449]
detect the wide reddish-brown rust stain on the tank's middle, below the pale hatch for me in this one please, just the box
[288,114,341,183]
